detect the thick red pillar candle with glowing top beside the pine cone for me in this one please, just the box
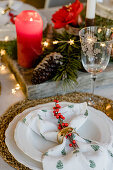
[15,10,43,68]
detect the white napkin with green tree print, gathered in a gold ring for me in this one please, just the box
[23,102,113,170]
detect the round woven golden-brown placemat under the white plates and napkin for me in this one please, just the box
[0,93,113,170]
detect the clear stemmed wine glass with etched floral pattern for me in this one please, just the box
[79,26,113,105]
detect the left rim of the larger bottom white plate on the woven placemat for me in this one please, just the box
[5,104,42,170]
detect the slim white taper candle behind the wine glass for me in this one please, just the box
[86,0,96,19]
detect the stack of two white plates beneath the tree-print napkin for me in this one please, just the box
[5,102,113,170]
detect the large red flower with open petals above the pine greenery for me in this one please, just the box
[52,0,83,29]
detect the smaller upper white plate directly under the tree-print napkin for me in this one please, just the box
[14,102,111,162]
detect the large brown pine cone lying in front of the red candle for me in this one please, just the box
[31,52,63,84]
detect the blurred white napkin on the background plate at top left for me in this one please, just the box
[0,1,23,25]
